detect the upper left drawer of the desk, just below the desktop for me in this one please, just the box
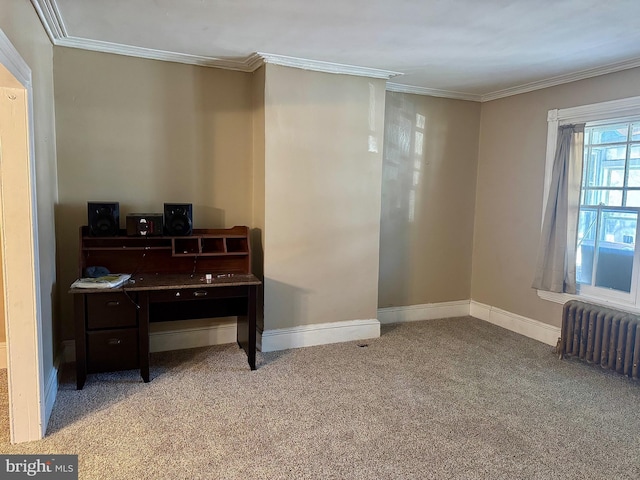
[87,292,137,330]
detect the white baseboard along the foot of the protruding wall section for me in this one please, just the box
[258,319,380,352]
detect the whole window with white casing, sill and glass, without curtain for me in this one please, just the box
[538,97,640,311]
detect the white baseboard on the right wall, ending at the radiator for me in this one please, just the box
[469,300,560,346]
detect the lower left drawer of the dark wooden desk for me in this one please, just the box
[87,328,139,372]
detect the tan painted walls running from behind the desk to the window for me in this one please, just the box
[48,20,640,346]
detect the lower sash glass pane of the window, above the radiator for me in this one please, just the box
[596,210,638,292]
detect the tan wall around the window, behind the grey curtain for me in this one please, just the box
[471,69,640,326]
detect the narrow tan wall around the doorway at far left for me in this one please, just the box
[0,0,57,368]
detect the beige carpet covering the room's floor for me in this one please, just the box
[0,317,640,479]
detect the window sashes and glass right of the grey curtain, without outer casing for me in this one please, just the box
[576,120,640,304]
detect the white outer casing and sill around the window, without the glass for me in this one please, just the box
[537,96,640,312]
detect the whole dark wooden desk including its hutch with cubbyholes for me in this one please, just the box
[69,227,261,390]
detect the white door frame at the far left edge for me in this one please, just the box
[0,29,46,443]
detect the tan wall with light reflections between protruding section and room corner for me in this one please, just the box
[379,92,480,307]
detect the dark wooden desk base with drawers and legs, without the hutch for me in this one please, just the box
[69,274,260,390]
